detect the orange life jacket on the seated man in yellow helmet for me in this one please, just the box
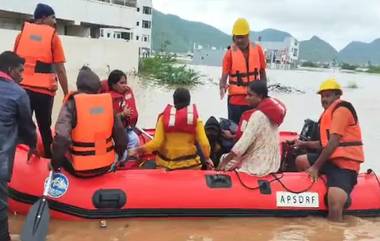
[320,100,364,162]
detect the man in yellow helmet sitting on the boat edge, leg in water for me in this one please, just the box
[294,79,364,221]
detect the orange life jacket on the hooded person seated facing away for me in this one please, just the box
[71,93,115,171]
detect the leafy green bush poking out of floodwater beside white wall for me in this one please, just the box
[139,53,201,87]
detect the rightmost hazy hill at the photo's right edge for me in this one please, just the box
[338,39,380,65]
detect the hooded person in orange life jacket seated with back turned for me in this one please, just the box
[52,67,127,177]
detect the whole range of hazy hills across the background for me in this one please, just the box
[152,10,380,64]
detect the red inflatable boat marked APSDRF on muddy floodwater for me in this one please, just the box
[9,132,380,220]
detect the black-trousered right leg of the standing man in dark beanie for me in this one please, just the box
[35,93,54,158]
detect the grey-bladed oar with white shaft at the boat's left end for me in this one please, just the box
[21,171,53,241]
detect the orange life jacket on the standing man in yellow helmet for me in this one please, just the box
[228,43,261,95]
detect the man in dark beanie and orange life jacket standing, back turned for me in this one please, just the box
[14,3,68,157]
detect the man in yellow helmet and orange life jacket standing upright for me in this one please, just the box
[219,18,267,123]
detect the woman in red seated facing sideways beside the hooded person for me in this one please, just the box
[102,70,140,149]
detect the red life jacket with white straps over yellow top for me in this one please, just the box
[162,105,198,134]
